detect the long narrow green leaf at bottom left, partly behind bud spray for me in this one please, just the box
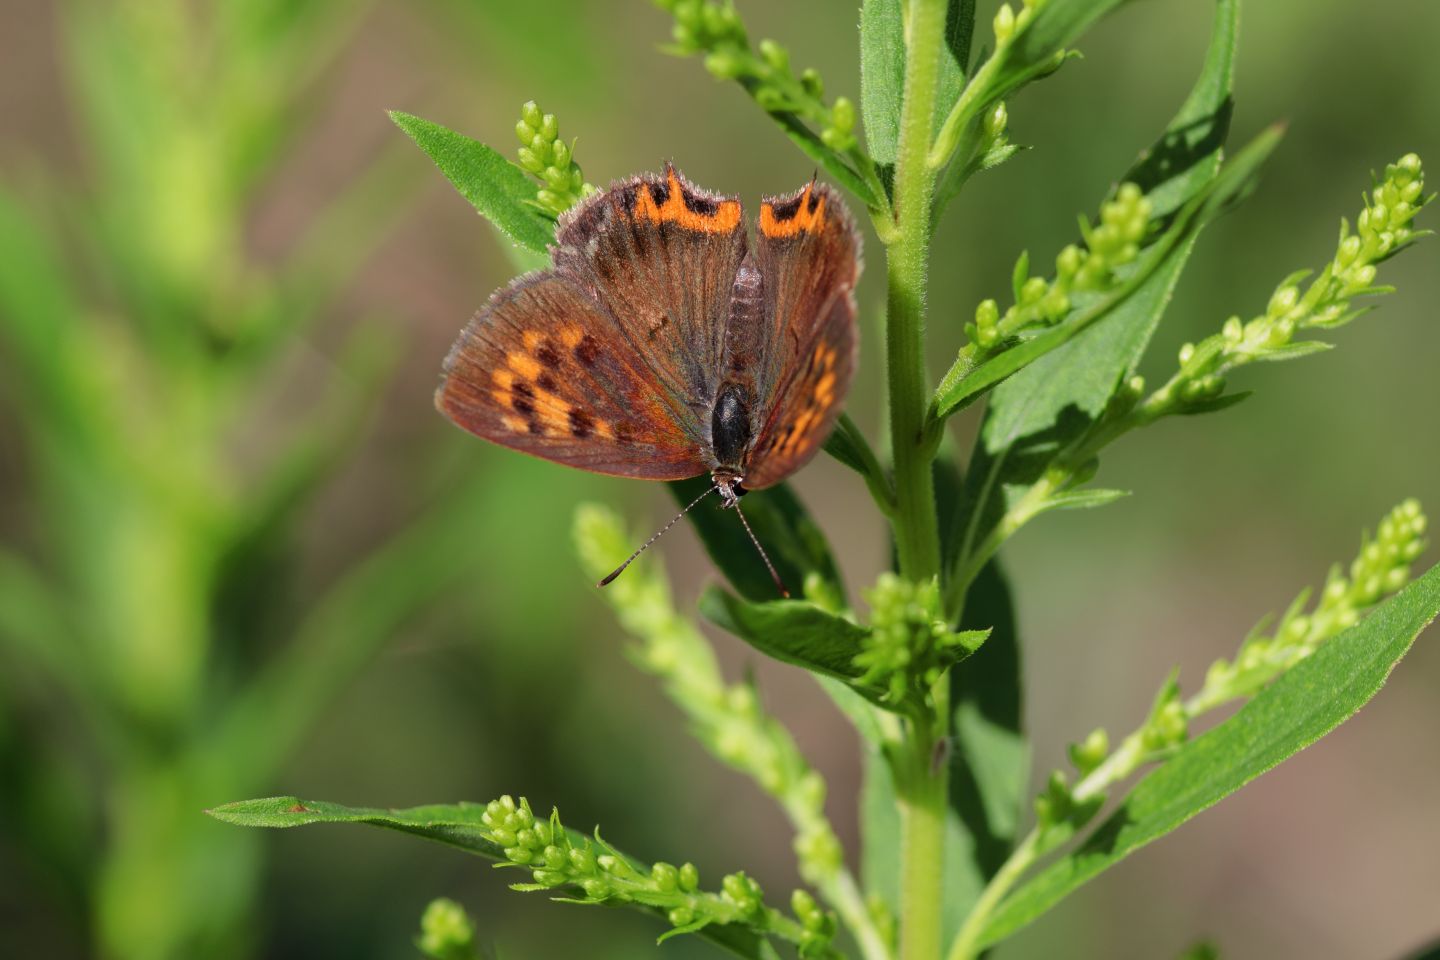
[206,796,775,960]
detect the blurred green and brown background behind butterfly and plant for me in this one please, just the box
[0,0,1440,960]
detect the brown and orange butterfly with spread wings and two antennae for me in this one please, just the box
[435,164,860,593]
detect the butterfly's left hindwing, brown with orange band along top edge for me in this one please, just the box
[554,164,746,417]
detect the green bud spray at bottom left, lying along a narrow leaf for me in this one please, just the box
[481,796,834,957]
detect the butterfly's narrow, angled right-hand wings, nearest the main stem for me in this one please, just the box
[724,183,860,489]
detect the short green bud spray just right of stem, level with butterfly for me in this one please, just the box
[965,184,1151,350]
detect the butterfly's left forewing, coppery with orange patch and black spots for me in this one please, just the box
[435,271,706,479]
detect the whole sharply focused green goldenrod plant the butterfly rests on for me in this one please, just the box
[197,0,1440,960]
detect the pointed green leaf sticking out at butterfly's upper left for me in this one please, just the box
[390,109,554,253]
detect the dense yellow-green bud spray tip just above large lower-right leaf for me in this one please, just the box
[1185,499,1427,715]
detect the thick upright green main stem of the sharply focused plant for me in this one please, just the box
[886,0,949,960]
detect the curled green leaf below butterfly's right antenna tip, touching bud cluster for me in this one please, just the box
[700,587,870,682]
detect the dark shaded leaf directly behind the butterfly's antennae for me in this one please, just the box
[668,476,845,606]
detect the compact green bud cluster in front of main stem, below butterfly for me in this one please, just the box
[854,573,976,708]
